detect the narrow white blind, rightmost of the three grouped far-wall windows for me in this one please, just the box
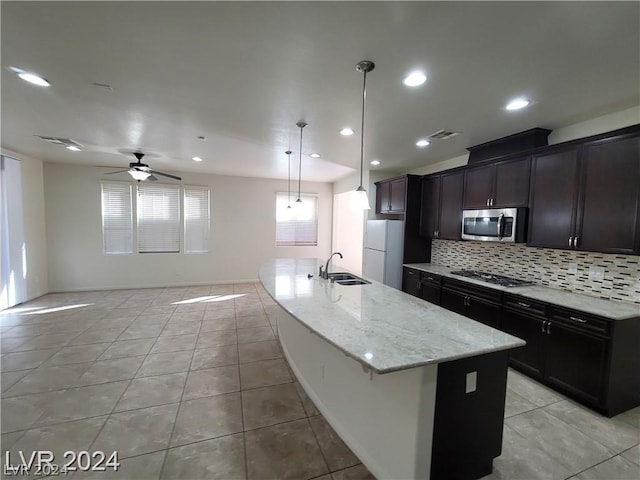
[184,186,210,253]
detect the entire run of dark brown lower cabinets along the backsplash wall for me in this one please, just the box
[403,274,640,417]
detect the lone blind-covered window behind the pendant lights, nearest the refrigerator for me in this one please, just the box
[276,193,318,247]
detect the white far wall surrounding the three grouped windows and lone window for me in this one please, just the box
[44,163,333,291]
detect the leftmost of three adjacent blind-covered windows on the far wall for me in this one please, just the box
[102,182,133,255]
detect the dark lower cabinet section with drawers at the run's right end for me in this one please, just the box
[502,294,640,417]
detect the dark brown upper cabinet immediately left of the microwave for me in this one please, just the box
[420,171,464,240]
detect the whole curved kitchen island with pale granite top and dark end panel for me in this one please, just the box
[260,259,525,479]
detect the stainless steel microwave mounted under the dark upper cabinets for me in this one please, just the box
[462,208,527,242]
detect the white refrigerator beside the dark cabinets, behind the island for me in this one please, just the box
[363,220,404,290]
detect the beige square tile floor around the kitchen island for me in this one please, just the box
[0,283,640,480]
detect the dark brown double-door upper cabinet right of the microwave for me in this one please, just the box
[528,127,640,254]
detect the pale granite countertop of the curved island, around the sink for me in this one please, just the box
[259,258,525,373]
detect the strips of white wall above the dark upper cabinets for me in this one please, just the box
[407,106,640,175]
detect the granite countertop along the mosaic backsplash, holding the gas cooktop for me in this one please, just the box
[404,263,640,320]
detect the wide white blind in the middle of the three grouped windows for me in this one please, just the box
[137,183,180,253]
